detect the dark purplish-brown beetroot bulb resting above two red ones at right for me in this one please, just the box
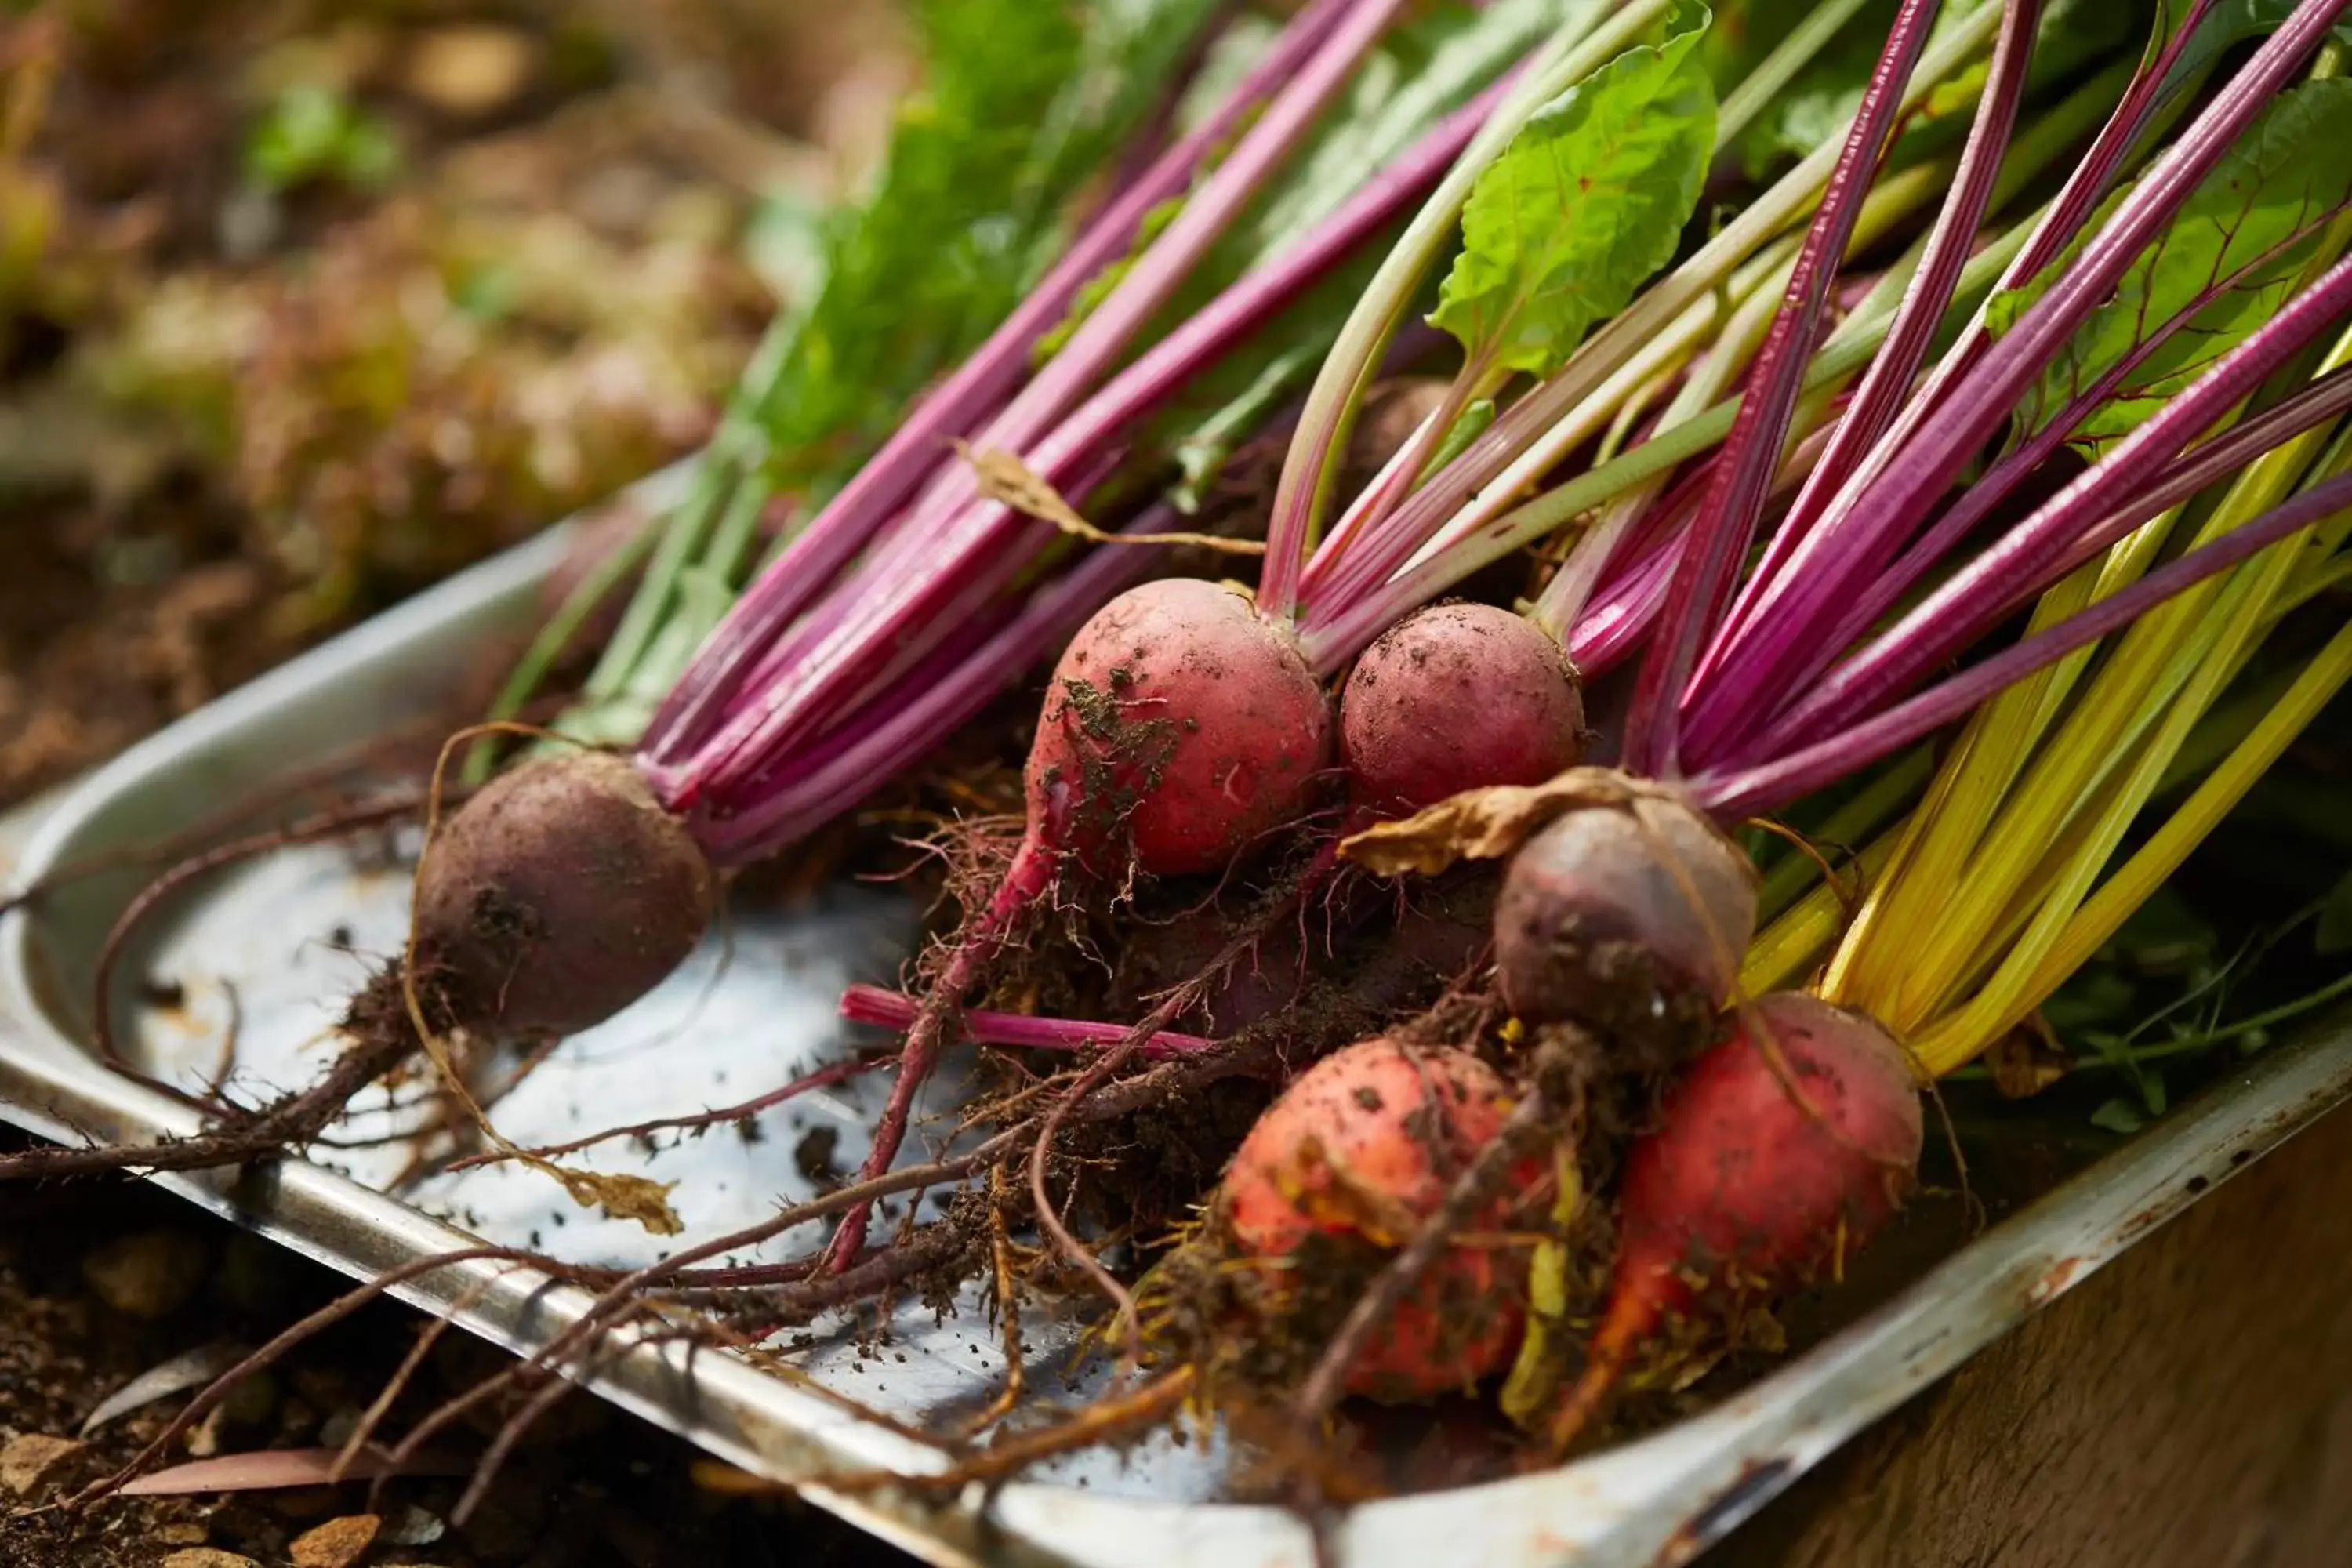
[1494,785,1757,1055]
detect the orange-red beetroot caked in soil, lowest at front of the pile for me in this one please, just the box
[1218,1039,1543,1401]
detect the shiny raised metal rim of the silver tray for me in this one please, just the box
[0,531,2352,1568]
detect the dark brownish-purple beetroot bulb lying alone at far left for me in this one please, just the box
[414,753,715,1036]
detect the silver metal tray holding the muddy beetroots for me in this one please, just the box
[0,517,2352,1568]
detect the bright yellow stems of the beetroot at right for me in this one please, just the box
[1778,314,2352,1074]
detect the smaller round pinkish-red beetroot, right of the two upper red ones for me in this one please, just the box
[1338,604,1585,818]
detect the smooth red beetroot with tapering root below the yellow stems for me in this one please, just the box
[1552,992,1924,1450]
